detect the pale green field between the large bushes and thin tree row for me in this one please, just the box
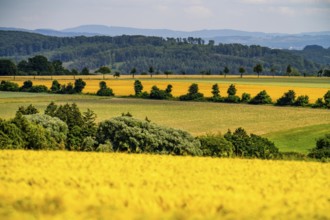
[0,92,330,152]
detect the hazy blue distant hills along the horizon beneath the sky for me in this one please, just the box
[0,25,330,50]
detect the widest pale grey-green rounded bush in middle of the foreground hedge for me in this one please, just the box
[96,117,202,156]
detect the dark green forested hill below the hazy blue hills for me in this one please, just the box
[0,31,330,74]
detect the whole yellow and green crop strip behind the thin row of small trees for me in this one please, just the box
[1,75,330,103]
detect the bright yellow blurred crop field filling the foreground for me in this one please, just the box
[0,151,330,219]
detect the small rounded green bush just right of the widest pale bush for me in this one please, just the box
[198,134,233,157]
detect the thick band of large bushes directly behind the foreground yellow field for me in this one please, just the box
[0,102,330,159]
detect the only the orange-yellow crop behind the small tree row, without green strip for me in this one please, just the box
[3,75,330,103]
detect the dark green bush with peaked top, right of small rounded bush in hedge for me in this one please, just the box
[224,128,279,159]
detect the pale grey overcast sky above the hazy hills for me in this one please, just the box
[0,0,330,33]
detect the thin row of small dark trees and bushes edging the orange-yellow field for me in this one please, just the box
[0,79,330,108]
